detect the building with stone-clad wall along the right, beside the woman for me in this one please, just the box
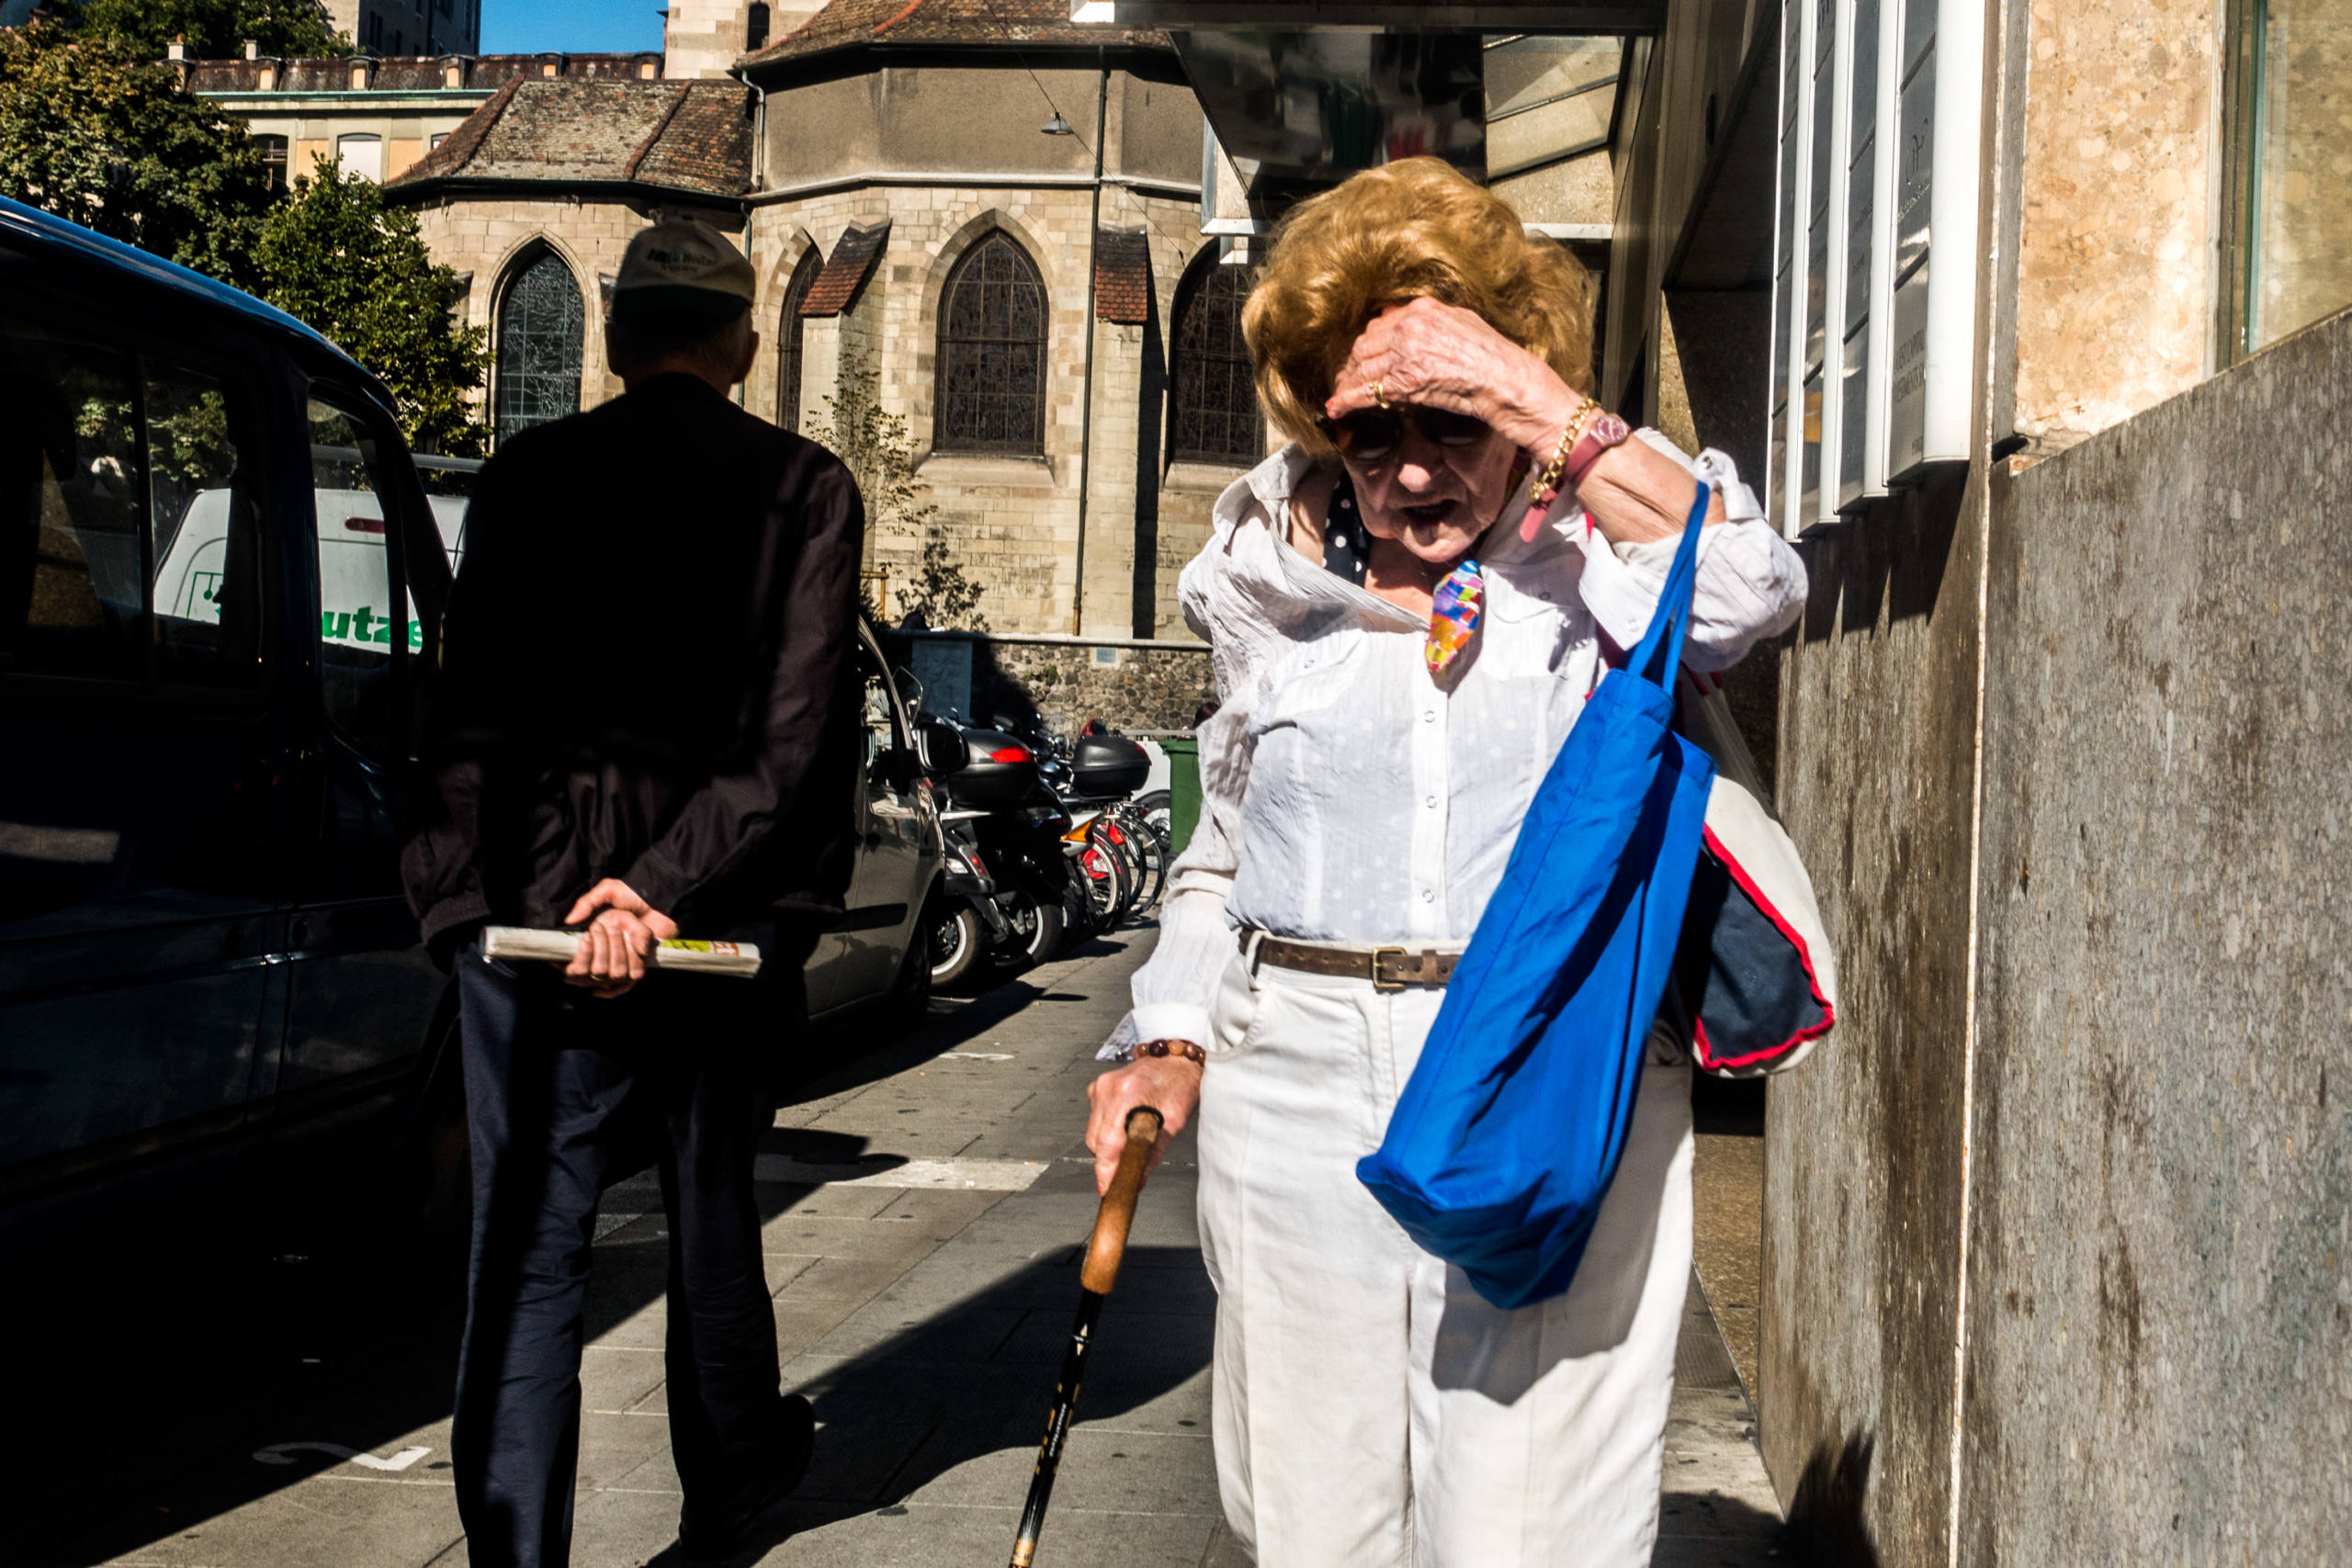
[1103,0,2352,1568]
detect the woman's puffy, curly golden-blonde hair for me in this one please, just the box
[1242,157,1592,454]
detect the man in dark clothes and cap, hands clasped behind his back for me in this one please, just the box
[404,221,865,1568]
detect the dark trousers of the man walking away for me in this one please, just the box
[449,942,799,1568]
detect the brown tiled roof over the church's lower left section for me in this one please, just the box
[383,77,751,195]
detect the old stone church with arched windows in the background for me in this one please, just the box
[386,0,1265,639]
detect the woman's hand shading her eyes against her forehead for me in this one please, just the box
[1324,299,1580,451]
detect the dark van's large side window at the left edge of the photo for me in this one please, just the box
[0,317,261,686]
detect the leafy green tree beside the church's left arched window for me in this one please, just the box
[254,157,489,456]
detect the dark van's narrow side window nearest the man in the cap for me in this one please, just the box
[311,398,409,757]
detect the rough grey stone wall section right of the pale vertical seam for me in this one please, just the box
[1962,315,2352,1563]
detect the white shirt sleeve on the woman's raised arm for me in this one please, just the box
[1571,430,1804,672]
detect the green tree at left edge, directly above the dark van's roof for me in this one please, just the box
[0,21,270,289]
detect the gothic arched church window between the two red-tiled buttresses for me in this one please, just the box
[932,231,1045,454]
